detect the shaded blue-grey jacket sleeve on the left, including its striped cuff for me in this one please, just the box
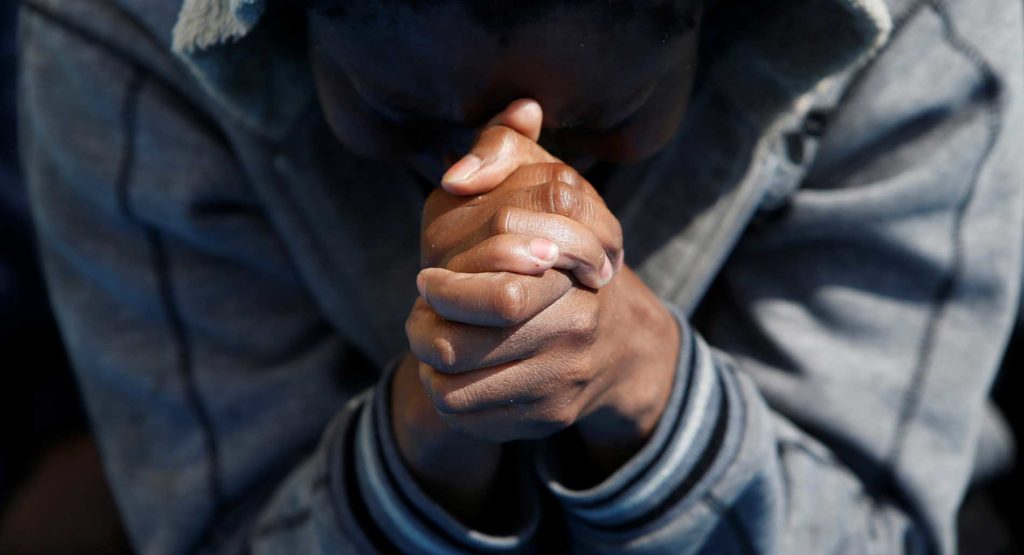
[19,3,536,554]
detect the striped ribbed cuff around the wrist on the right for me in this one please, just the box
[538,305,742,532]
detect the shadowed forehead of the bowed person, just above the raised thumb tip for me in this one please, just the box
[313,2,685,125]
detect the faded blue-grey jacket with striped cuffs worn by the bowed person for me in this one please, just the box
[19,0,1024,554]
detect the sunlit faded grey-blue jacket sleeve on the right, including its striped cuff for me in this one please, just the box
[539,1,1024,553]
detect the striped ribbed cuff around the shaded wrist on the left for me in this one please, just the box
[353,364,540,554]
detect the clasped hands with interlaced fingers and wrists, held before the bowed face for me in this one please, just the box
[392,100,679,514]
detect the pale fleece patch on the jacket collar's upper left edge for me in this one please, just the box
[173,0,265,53]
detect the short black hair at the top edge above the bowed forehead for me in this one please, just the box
[308,0,705,42]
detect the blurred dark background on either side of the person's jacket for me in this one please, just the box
[0,1,1024,554]
